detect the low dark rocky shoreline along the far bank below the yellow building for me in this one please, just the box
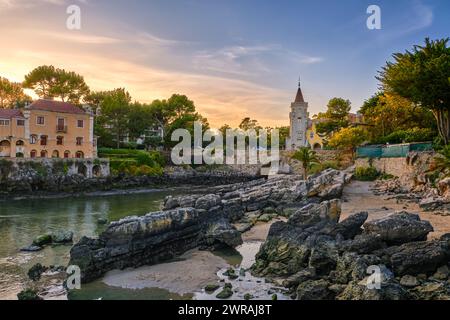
[0,170,262,201]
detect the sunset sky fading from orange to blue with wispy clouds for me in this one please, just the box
[0,0,450,127]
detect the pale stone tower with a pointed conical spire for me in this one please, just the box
[286,81,309,150]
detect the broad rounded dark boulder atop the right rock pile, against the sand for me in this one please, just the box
[364,212,433,244]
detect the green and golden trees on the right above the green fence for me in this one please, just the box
[308,38,450,151]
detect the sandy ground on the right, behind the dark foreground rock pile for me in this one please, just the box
[341,181,450,239]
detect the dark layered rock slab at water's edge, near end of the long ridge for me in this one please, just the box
[70,208,242,282]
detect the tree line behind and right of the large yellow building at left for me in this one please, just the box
[0,65,209,148]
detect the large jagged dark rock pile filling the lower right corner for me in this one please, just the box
[252,200,450,300]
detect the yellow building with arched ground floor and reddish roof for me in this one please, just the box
[0,100,97,158]
